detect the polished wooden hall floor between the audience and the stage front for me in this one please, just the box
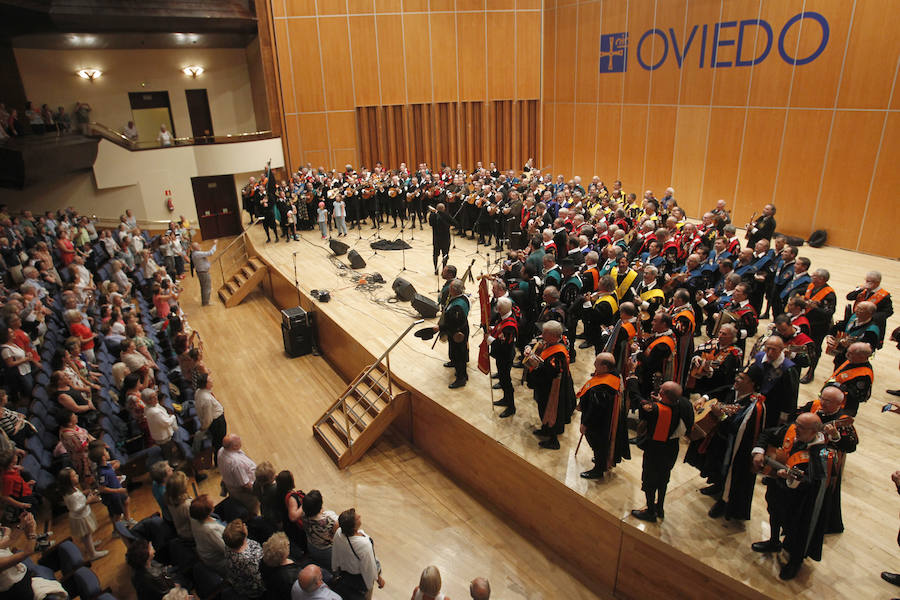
[70,270,606,600]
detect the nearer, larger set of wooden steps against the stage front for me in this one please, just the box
[313,360,410,469]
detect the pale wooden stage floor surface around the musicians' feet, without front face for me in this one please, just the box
[250,221,900,599]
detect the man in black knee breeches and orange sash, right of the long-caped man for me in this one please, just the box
[628,378,694,523]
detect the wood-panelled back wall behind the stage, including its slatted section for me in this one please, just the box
[265,0,542,175]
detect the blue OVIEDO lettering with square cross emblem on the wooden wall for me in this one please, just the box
[600,11,830,73]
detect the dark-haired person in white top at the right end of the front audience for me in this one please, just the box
[331,508,384,600]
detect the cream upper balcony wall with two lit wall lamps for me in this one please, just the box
[15,48,265,137]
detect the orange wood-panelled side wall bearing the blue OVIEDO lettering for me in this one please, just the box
[539,0,900,258]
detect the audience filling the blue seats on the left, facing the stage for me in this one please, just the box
[0,206,506,600]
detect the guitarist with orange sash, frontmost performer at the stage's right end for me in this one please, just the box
[752,412,835,580]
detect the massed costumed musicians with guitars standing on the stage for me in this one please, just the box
[237,160,900,579]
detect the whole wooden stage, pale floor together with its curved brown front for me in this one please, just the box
[243,224,900,599]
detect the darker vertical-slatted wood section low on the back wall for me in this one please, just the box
[356,100,540,169]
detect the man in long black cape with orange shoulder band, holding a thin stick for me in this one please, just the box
[576,352,631,479]
